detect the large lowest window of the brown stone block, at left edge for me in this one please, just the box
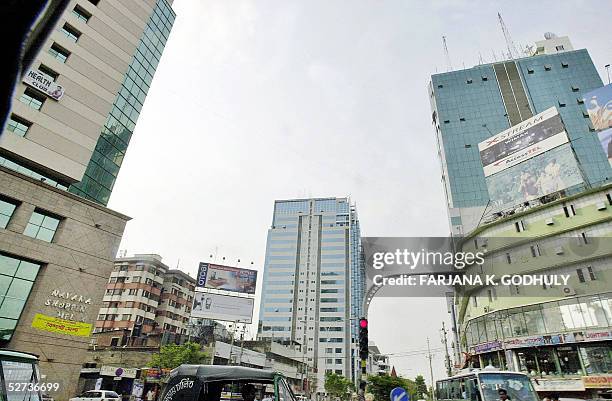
[0,254,41,341]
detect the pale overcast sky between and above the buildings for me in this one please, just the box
[109,0,612,378]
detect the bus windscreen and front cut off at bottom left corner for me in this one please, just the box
[0,349,42,401]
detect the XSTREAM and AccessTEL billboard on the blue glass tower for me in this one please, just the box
[478,107,568,177]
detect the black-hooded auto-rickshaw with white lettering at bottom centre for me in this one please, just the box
[159,365,296,401]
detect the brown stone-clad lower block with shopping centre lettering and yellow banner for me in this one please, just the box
[0,167,129,400]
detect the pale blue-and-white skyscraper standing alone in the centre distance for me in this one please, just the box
[258,198,365,391]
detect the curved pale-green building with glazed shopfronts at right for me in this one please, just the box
[457,184,612,398]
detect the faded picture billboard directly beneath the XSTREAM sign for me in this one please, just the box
[486,143,583,207]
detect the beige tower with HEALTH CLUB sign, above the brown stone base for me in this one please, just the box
[0,0,175,205]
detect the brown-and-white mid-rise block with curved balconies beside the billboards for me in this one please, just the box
[95,254,195,345]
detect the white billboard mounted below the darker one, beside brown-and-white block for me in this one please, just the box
[191,292,255,323]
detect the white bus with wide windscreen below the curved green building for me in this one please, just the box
[435,367,539,401]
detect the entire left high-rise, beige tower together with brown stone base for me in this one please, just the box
[0,0,175,400]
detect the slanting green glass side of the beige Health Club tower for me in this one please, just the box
[69,0,176,205]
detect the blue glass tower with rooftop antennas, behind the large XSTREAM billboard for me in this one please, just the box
[429,34,612,235]
